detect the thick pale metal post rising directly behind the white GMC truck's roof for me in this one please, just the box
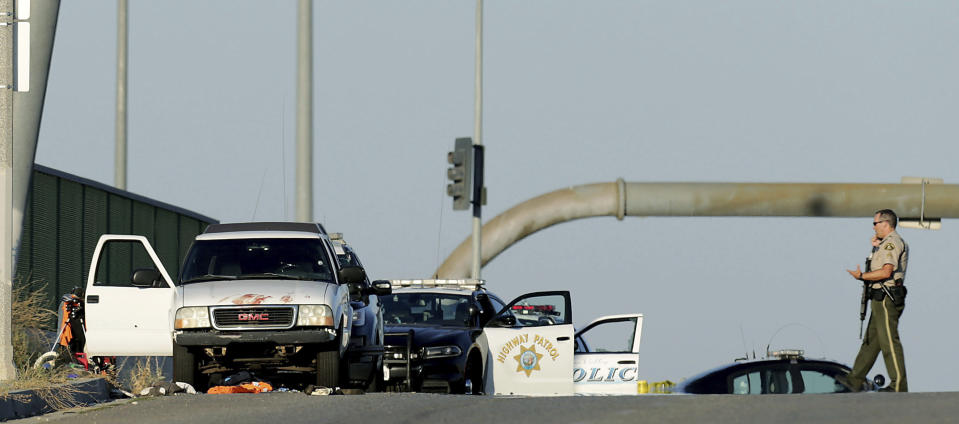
[296,0,313,222]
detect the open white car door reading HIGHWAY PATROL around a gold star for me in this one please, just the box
[479,291,573,395]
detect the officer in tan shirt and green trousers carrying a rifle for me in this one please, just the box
[839,209,909,392]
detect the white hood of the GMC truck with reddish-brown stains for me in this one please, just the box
[180,280,336,306]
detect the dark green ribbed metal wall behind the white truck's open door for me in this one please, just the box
[14,165,218,309]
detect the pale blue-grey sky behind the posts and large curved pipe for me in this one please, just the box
[36,0,959,391]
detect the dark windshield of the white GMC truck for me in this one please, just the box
[180,238,333,284]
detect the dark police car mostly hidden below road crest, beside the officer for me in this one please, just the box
[674,350,885,395]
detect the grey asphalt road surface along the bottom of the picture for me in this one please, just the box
[9,392,959,424]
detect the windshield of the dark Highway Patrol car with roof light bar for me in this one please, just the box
[381,293,471,327]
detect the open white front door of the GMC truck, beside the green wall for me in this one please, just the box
[84,234,175,356]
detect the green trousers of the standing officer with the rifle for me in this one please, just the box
[849,296,908,392]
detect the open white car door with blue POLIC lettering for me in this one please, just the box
[573,314,643,394]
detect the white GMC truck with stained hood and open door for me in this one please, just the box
[84,222,390,389]
